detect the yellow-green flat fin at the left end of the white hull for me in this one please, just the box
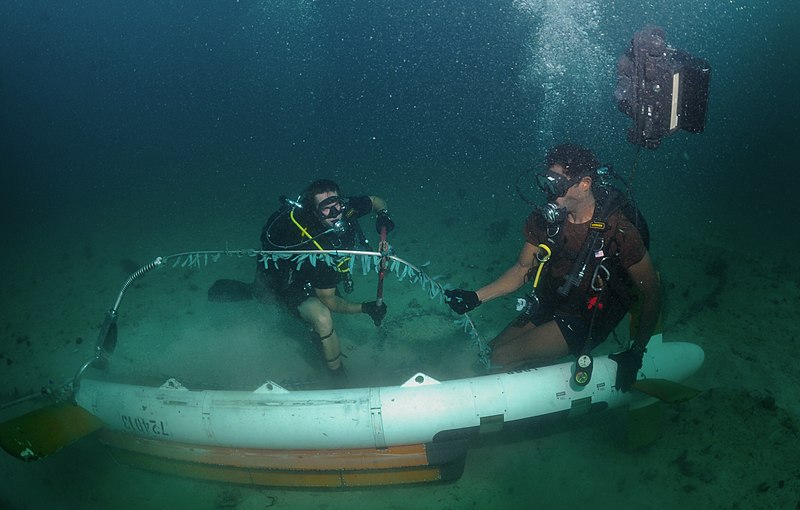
[0,402,104,461]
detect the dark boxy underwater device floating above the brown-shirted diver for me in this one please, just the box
[614,25,711,149]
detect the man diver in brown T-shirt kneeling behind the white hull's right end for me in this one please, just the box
[446,144,661,391]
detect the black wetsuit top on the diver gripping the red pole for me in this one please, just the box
[261,196,372,295]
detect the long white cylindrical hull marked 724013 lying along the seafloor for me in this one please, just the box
[76,337,704,450]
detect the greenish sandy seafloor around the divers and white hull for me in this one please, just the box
[0,167,800,510]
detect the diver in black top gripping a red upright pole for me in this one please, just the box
[254,179,394,379]
